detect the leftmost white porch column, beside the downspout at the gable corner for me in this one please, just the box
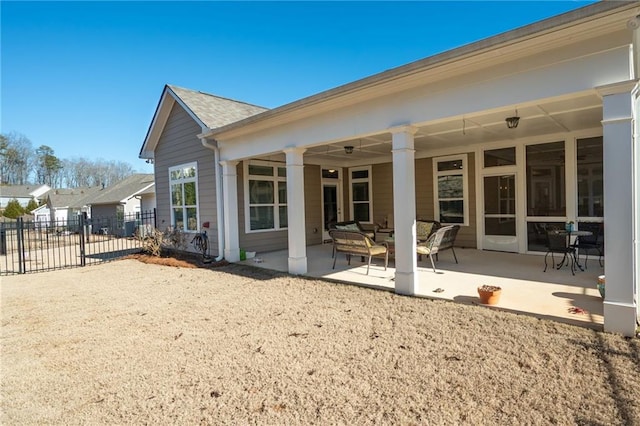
[220,161,240,262]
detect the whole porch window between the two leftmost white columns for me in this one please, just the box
[245,161,288,231]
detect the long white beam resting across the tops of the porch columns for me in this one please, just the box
[218,46,630,160]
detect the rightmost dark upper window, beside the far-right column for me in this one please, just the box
[577,136,604,218]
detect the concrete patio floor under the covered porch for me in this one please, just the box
[240,244,604,330]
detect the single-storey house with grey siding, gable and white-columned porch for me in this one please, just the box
[140,2,640,336]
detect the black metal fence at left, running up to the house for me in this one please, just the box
[0,209,156,275]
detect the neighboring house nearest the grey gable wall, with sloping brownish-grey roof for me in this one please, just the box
[87,174,155,219]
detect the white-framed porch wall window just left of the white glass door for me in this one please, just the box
[433,154,469,225]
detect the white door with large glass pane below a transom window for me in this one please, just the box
[482,173,518,253]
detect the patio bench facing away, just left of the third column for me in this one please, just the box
[329,229,389,275]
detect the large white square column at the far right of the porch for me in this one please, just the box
[598,82,638,336]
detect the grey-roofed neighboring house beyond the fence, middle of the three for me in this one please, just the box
[32,186,101,228]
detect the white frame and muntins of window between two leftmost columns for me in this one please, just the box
[243,160,289,234]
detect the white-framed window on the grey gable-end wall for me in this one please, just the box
[169,163,199,231]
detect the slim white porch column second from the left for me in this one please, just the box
[284,148,307,275]
